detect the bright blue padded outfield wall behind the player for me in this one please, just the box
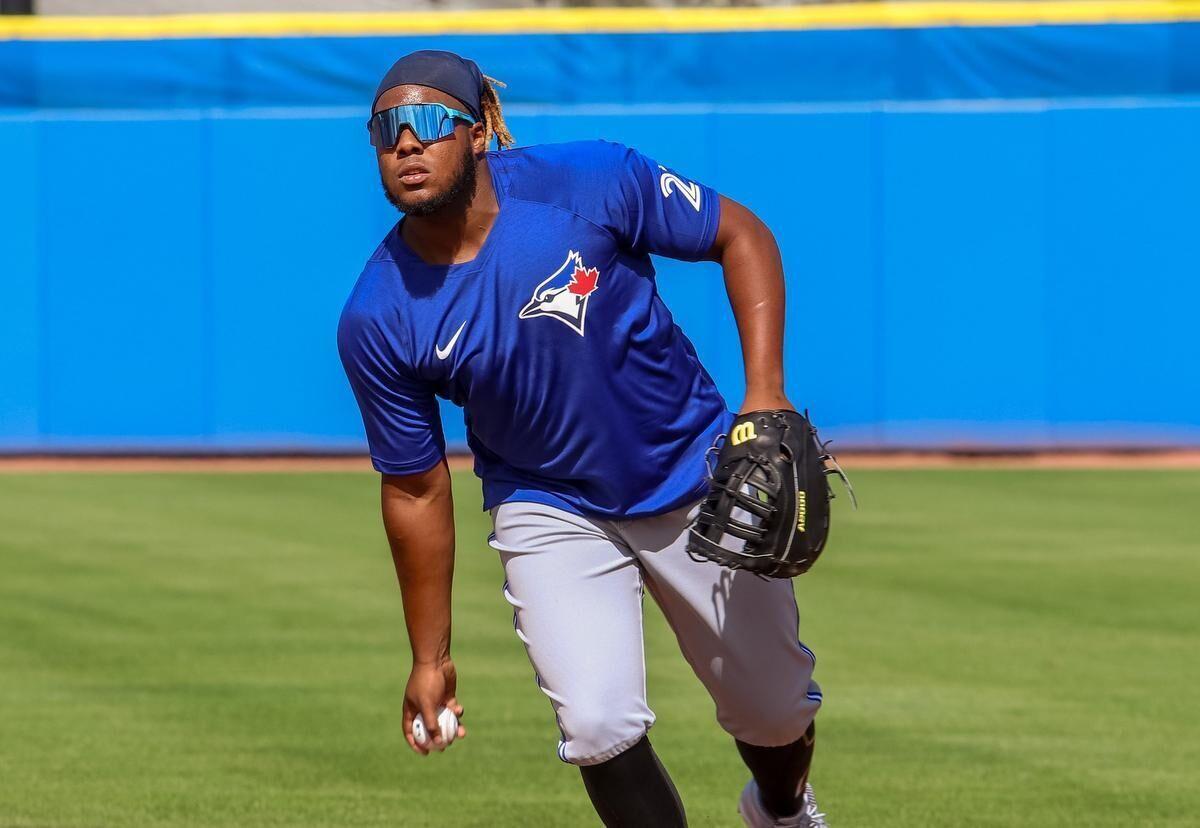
[0,17,1200,451]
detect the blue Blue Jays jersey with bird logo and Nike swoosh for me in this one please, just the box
[337,140,732,517]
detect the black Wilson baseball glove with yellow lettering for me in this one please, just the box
[688,410,858,578]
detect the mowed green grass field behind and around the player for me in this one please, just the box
[0,470,1200,828]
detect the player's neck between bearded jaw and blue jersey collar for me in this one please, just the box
[401,160,500,264]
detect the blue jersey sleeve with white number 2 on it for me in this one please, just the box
[610,146,721,262]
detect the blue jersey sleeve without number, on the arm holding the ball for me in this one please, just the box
[337,300,445,474]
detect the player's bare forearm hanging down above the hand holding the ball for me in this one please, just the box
[382,464,455,665]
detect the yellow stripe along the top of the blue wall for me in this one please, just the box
[0,0,1200,40]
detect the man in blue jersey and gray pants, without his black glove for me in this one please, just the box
[338,52,824,826]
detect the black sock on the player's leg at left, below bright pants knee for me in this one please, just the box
[580,737,688,828]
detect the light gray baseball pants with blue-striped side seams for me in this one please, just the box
[488,494,821,764]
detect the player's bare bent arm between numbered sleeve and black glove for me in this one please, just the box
[713,197,790,410]
